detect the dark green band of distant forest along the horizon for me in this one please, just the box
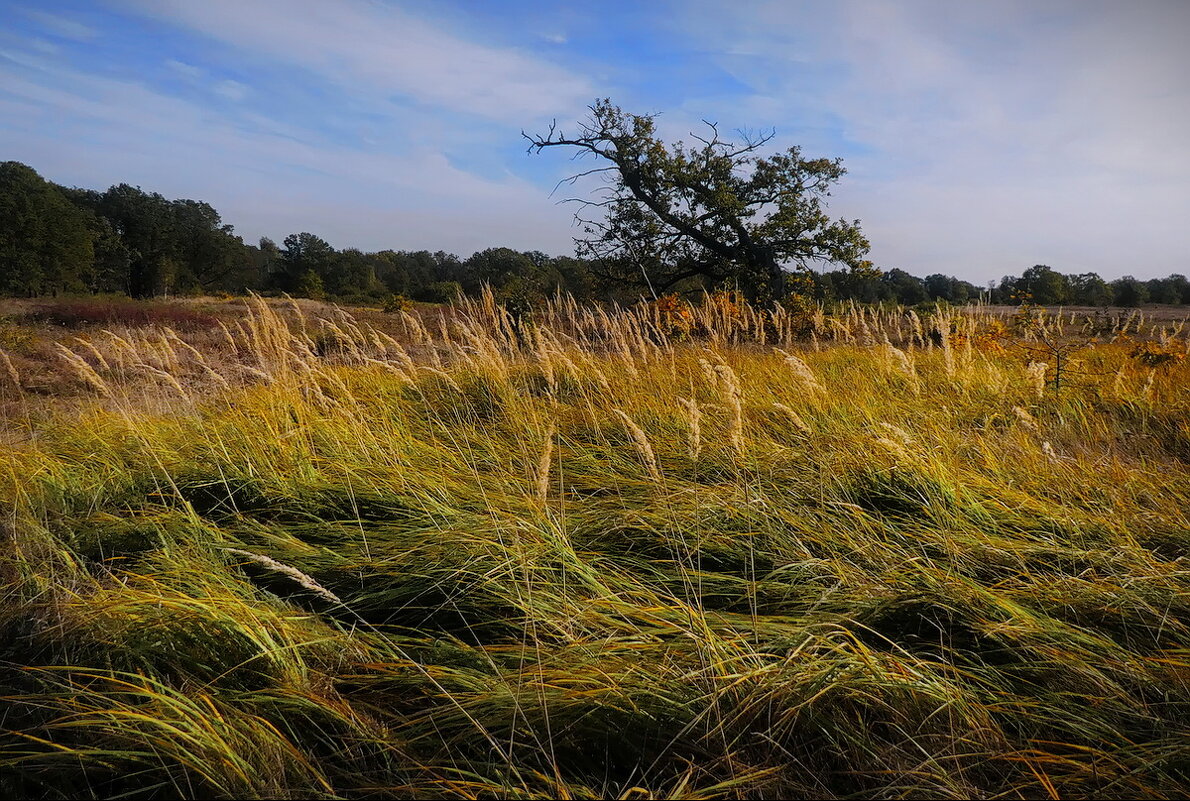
[0,162,1190,306]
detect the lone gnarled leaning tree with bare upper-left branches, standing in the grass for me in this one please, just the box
[524,99,872,299]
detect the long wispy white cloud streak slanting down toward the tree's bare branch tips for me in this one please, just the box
[114,0,595,124]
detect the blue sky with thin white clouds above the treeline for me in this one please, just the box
[0,0,1190,283]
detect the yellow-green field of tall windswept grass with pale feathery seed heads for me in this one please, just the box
[0,298,1190,799]
